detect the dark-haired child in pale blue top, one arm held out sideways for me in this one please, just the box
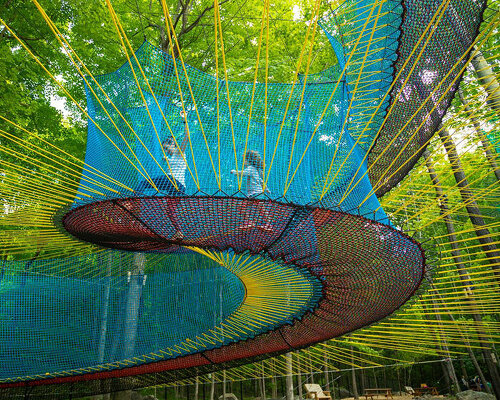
[231,150,273,231]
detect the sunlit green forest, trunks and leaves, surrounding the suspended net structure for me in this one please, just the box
[0,0,500,398]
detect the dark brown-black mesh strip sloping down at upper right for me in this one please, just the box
[368,0,487,196]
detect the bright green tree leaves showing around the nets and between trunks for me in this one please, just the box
[0,0,500,380]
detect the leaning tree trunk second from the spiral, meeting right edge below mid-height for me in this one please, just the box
[439,128,500,283]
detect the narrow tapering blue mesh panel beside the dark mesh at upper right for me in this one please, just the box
[320,0,403,151]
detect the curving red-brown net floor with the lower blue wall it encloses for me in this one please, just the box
[1,197,424,397]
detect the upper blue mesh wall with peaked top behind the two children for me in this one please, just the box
[77,29,390,219]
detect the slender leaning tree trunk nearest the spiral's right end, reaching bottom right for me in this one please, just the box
[423,150,500,399]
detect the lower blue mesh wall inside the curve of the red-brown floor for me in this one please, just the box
[0,251,321,382]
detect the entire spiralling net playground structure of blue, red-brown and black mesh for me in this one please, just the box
[0,0,485,398]
